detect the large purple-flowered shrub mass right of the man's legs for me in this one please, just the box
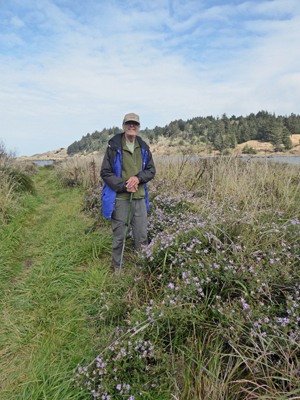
[142,192,300,342]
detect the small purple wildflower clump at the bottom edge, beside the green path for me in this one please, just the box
[73,328,164,400]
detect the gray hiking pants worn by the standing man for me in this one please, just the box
[111,199,148,267]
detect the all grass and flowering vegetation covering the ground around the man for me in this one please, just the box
[0,157,300,400]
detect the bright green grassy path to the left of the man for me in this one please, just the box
[0,168,110,400]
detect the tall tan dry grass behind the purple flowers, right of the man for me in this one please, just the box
[155,157,300,214]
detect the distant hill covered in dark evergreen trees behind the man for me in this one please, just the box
[68,111,300,156]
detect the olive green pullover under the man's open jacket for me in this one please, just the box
[117,135,145,199]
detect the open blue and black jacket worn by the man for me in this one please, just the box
[100,132,155,219]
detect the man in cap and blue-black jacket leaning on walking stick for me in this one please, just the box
[100,113,155,268]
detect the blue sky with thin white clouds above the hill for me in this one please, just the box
[0,0,300,156]
